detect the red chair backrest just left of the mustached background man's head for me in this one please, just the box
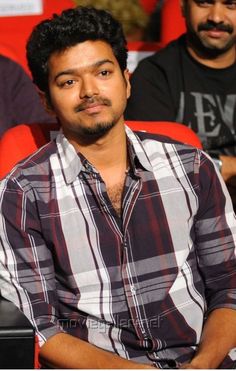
[160,0,186,45]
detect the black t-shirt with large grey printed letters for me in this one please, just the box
[125,36,236,155]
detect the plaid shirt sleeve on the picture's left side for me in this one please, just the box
[0,178,64,345]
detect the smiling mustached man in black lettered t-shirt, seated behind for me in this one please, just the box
[126,0,236,203]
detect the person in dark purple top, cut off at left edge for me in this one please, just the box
[0,55,53,137]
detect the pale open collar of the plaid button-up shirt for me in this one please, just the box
[56,126,152,184]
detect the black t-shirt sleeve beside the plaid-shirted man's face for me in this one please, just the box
[125,58,176,121]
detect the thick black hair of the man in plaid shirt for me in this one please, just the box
[26,7,127,94]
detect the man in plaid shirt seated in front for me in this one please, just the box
[0,7,236,369]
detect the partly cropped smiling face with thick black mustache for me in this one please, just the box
[182,0,236,54]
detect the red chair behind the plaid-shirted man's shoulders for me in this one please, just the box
[0,121,202,179]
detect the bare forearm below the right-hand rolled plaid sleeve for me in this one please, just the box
[183,308,236,369]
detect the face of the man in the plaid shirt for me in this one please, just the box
[48,41,130,140]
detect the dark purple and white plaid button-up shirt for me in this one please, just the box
[0,128,236,367]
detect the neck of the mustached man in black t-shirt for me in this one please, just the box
[187,45,236,69]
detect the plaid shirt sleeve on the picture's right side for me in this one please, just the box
[195,153,236,312]
